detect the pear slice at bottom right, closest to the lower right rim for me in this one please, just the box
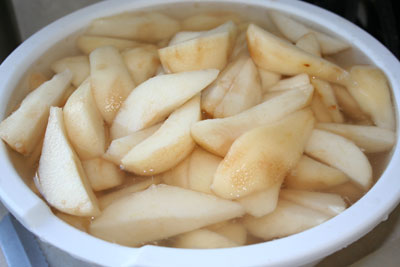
[243,199,331,240]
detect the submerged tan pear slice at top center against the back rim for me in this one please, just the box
[181,12,241,31]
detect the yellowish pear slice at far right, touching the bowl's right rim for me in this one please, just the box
[347,66,395,130]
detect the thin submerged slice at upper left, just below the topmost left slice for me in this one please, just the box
[76,35,140,55]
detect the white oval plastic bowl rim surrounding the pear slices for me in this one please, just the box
[0,0,400,266]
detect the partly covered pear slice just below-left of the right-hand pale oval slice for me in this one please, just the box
[285,156,349,191]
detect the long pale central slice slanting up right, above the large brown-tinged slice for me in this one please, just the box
[192,85,313,157]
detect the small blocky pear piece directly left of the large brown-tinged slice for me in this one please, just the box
[187,147,222,194]
